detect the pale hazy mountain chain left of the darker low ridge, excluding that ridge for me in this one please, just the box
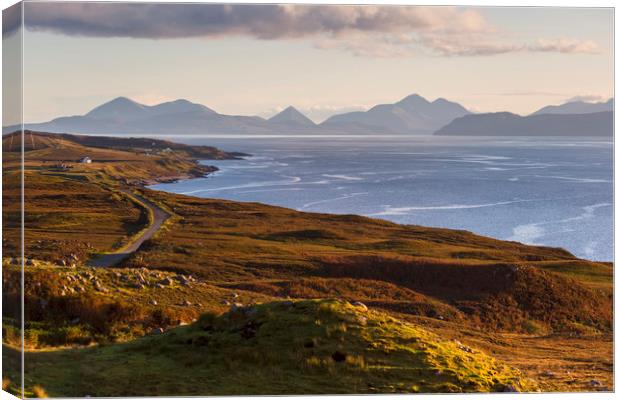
[3,95,469,134]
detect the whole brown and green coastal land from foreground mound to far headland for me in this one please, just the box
[3,133,613,396]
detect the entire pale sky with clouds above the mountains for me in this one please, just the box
[3,2,613,125]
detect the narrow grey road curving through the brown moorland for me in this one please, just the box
[86,190,170,267]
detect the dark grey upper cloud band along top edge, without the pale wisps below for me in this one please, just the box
[8,2,488,39]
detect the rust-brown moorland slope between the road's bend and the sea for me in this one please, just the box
[128,191,612,332]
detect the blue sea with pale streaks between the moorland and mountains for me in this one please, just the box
[153,137,613,261]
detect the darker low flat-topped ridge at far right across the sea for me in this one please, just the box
[435,111,613,137]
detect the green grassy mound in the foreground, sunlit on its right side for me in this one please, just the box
[4,300,536,397]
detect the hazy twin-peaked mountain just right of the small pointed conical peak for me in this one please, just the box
[321,94,469,134]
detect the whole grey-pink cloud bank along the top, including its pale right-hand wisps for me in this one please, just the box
[4,2,598,57]
